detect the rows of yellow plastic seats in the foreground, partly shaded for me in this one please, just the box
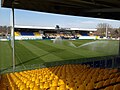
[0,64,120,90]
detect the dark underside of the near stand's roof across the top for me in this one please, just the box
[2,0,120,20]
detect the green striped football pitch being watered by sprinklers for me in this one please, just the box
[0,40,118,73]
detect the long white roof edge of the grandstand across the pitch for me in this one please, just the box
[15,25,97,31]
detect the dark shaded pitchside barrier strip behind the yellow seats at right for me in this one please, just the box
[44,56,120,68]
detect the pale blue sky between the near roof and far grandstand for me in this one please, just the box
[0,0,120,28]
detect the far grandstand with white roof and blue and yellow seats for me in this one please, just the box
[15,25,97,40]
